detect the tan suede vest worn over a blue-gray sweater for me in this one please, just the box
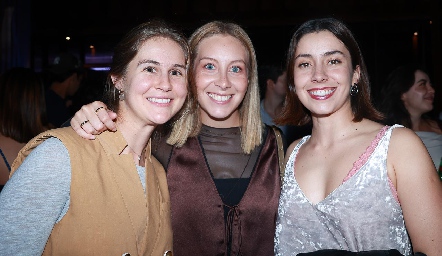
[12,127,172,256]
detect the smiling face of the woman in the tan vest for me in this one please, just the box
[112,37,187,126]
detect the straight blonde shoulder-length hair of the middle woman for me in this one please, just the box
[167,21,263,154]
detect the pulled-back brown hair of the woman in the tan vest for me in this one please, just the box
[104,20,189,125]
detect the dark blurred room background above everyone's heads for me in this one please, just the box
[0,0,442,113]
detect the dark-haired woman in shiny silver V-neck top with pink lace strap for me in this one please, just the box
[275,18,442,256]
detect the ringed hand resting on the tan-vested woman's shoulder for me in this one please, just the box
[71,101,117,140]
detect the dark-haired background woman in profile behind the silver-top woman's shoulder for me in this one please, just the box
[379,63,442,168]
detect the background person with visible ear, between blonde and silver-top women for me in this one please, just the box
[258,63,311,145]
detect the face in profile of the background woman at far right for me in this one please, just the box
[401,70,434,116]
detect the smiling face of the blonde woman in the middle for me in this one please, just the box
[193,35,248,127]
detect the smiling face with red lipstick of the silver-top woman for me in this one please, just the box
[294,31,359,117]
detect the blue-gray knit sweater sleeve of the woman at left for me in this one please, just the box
[0,138,71,255]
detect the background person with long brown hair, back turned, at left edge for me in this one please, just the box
[0,67,48,191]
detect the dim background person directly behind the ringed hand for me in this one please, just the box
[44,52,83,128]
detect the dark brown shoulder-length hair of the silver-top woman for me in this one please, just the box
[275,18,383,125]
